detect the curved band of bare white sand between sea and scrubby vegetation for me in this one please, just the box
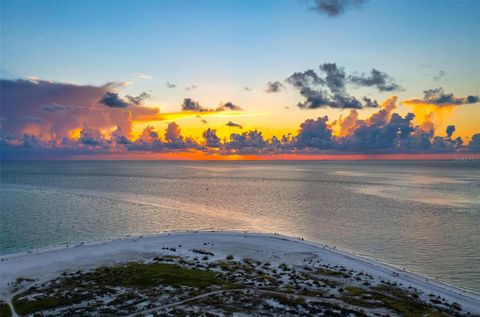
[0,231,480,315]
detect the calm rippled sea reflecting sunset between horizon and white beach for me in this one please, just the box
[0,161,480,293]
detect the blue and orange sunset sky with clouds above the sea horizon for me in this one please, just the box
[0,0,480,159]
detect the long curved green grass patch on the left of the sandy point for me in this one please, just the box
[10,262,229,316]
